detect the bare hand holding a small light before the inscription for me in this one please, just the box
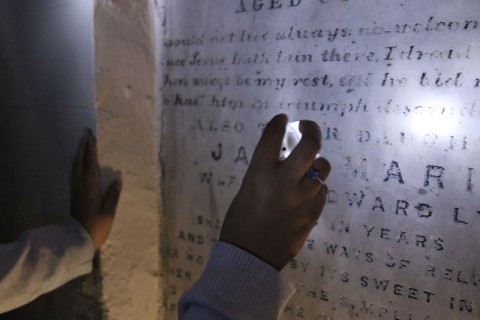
[220,114,330,270]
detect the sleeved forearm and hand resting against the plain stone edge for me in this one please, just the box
[0,130,121,313]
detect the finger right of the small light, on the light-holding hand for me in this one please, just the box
[285,120,321,180]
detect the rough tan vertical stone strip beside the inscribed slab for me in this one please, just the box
[95,0,161,320]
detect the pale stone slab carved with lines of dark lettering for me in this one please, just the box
[159,0,480,320]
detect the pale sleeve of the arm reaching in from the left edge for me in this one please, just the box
[0,218,94,314]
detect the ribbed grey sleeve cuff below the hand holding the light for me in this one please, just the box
[179,242,295,320]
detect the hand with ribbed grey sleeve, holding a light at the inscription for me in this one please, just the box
[179,115,330,319]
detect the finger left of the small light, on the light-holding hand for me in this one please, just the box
[252,114,288,168]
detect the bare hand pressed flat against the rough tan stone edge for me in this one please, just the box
[70,129,122,250]
